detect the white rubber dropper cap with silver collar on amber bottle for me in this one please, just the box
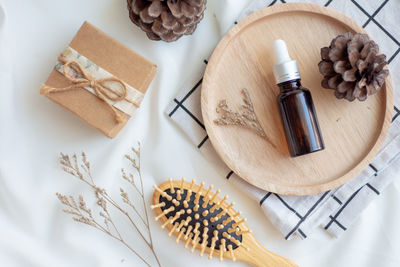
[273,39,300,84]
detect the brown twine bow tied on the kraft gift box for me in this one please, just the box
[44,55,130,123]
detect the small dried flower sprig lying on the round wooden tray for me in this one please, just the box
[214,89,267,139]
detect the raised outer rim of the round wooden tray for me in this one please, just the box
[201,3,393,195]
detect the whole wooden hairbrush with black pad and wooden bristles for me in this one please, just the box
[151,178,297,267]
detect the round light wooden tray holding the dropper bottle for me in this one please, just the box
[201,3,393,195]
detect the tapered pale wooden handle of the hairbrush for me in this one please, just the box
[241,239,298,267]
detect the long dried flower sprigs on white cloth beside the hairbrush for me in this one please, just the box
[56,143,161,266]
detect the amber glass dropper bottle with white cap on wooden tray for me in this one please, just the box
[273,40,325,157]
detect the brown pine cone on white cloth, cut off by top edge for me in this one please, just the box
[127,0,207,42]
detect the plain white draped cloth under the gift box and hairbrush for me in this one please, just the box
[0,0,400,267]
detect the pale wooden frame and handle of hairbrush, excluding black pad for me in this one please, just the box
[153,180,298,267]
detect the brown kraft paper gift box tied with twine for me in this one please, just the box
[40,22,157,138]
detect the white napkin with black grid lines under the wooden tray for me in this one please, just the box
[165,0,400,239]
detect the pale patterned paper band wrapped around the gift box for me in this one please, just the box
[55,47,144,116]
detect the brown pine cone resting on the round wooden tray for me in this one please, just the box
[318,32,389,101]
